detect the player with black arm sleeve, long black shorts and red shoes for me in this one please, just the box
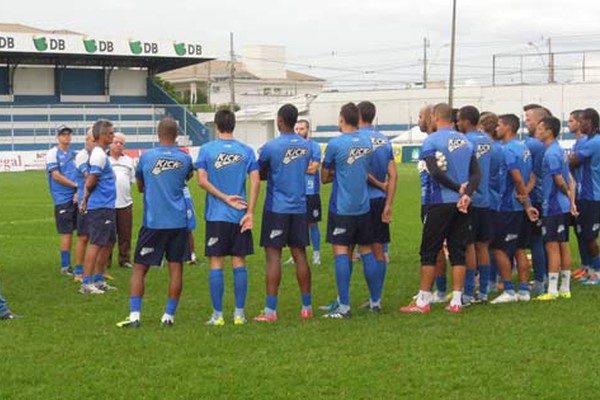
[400,103,480,313]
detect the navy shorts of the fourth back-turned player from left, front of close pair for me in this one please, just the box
[327,212,374,247]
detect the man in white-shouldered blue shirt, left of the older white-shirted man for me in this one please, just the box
[79,119,117,294]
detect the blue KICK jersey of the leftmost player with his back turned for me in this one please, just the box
[135,146,193,229]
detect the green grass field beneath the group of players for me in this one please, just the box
[0,166,600,399]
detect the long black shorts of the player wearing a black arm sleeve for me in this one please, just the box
[420,203,470,265]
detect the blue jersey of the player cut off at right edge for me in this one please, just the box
[575,134,600,201]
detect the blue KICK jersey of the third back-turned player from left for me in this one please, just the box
[258,133,314,214]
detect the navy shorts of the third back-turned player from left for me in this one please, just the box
[260,210,309,249]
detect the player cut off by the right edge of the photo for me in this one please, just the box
[569,108,600,285]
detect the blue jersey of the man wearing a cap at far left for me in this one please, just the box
[46,146,77,205]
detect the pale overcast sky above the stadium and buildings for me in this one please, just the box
[0,0,600,87]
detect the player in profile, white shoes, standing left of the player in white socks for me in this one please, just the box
[490,114,539,304]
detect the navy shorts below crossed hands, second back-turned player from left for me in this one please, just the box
[204,221,254,257]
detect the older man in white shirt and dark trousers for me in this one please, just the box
[110,133,135,268]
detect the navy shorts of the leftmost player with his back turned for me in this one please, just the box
[134,226,190,266]
